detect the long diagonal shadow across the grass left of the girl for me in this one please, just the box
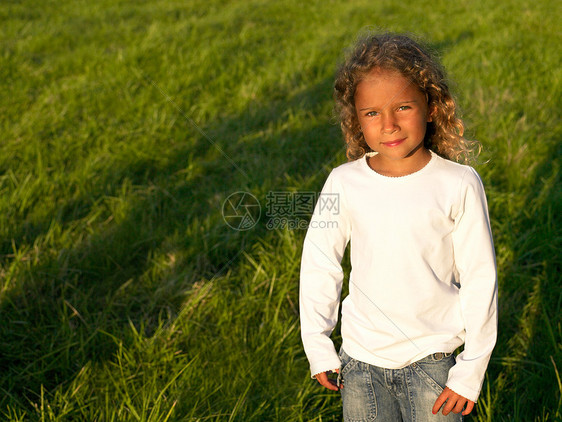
[0,73,341,412]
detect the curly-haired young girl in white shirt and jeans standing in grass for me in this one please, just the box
[300,34,497,422]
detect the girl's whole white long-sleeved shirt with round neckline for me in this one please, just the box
[300,152,497,401]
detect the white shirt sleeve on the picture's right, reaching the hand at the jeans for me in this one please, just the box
[447,168,498,401]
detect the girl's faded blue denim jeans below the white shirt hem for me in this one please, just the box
[340,349,463,422]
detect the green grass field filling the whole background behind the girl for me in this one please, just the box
[0,0,562,422]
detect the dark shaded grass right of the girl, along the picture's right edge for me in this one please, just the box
[483,139,562,420]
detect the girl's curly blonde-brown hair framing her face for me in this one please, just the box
[334,33,480,162]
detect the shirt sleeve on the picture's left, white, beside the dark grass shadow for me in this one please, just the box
[299,171,351,377]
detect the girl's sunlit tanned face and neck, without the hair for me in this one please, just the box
[355,69,431,176]
